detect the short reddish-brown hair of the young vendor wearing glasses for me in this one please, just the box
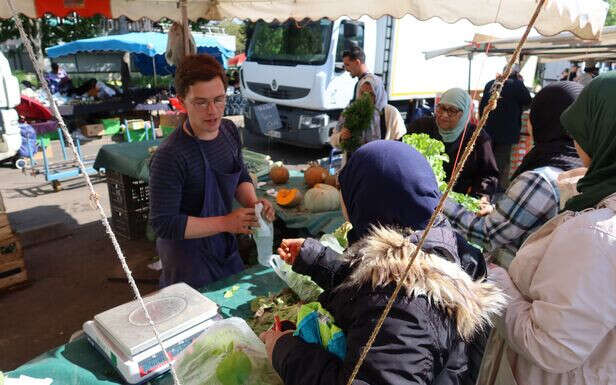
[175,54,227,98]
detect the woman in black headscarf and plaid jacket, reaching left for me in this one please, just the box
[443,81,584,267]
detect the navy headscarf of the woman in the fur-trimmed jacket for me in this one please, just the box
[339,140,441,244]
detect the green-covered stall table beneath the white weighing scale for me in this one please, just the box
[6,266,286,385]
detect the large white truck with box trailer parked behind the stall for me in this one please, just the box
[240,15,536,148]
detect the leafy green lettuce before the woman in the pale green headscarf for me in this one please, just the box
[402,134,479,212]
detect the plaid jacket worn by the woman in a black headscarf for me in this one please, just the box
[444,167,562,267]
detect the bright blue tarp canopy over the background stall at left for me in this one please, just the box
[47,32,235,75]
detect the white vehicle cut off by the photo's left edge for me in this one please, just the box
[0,52,21,163]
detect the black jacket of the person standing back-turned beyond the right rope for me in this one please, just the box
[479,75,532,144]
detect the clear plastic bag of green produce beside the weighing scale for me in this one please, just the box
[175,318,282,385]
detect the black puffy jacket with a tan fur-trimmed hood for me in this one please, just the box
[273,222,503,385]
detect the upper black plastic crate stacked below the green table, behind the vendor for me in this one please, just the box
[107,170,150,211]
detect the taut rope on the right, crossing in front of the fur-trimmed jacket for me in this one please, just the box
[347,0,546,385]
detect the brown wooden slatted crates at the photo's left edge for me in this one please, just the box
[0,212,28,289]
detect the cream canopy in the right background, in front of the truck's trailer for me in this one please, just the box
[425,26,616,63]
